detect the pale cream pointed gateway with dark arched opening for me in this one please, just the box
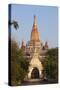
[28,52,43,79]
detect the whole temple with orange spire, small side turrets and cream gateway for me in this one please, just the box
[21,16,48,79]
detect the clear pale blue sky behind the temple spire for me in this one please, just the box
[11,4,58,48]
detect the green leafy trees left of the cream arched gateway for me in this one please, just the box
[11,41,29,85]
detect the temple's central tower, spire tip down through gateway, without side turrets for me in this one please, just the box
[27,16,43,79]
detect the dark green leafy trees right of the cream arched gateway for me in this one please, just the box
[44,48,58,81]
